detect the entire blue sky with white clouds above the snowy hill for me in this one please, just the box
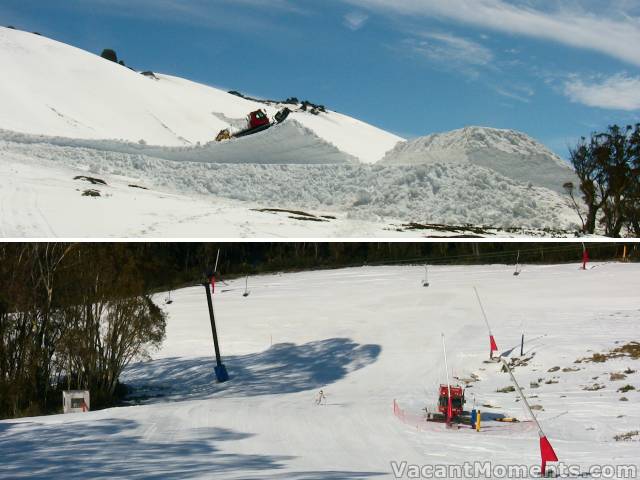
[0,0,640,157]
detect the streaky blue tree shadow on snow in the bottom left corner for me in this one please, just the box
[0,419,380,480]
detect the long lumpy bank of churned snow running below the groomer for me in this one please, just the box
[0,135,576,232]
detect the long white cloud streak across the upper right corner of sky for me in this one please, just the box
[342,0,640,65]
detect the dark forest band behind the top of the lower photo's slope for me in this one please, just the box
[104,242,640,291]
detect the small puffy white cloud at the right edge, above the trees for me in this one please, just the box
[564,74,640,111]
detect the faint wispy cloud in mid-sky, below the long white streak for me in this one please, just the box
[406,32,494,77]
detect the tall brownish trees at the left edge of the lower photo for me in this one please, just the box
[0,243,165,418]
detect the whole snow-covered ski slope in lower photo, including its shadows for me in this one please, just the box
[0,263,640,480]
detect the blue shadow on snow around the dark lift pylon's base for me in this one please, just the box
[122,338,381,403]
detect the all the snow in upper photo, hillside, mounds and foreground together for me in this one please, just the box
[0,27,578,232]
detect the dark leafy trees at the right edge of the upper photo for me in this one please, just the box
[564,124,640,237]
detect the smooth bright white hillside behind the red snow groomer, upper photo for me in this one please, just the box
[0,27,402,163]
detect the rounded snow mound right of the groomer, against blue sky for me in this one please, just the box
[380,127,578,193]
